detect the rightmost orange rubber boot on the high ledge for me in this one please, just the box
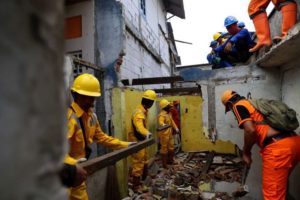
[273,3,297,43]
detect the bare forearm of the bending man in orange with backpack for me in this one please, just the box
[243,121,257,167]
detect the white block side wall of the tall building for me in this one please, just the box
[120,0,170,87]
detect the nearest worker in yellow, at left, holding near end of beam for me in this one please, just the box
[67,74,133,200]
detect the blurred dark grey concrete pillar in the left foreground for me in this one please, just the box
[0,0,66,200]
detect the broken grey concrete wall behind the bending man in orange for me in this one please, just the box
[177,1,300,199]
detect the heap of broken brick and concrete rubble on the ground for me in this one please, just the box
[126,152,243,200]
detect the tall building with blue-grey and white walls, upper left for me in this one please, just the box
[65,0,185,134]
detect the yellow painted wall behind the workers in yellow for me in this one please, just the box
[112,88,236,197]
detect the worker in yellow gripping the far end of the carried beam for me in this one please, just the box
[128,90,156,190]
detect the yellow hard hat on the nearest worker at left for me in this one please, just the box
[71,74,101,97]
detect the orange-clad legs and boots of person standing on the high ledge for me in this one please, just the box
[248,0,297,52]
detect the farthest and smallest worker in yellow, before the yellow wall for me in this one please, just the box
[158,99,179,169]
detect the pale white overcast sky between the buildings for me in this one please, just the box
[168,0,272,65]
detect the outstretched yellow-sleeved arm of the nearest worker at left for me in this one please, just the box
[94,120,129,149]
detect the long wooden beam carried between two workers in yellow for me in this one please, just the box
[79,138,155,174]
